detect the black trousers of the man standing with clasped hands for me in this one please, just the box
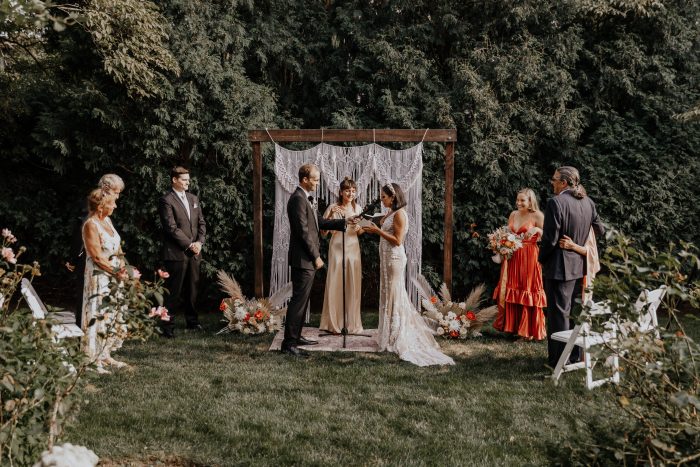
[161,257,200,331]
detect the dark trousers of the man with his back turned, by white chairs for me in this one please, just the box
[544,279,583,368]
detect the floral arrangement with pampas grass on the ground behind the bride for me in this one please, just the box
[413,275,498,339]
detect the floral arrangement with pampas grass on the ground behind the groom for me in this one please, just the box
[217,271,292,335]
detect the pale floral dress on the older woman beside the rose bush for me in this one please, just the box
[82,218,126,366]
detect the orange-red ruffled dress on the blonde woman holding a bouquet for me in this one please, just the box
[493,222,547,340]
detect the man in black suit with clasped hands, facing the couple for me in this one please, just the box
[158,167,206,337]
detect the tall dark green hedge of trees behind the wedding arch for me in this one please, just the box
[0,0,700,300]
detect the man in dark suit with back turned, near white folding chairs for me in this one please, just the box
[539,166,605,368]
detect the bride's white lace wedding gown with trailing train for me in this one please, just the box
[377,211,454,366]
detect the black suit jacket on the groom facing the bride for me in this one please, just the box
[287,188,345,269]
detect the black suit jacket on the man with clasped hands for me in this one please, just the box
[158,190,207,261]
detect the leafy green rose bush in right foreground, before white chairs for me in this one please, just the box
[561,232,700,465]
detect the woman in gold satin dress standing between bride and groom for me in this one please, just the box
[320,177,363,334]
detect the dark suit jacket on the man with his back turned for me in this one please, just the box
[539,190,605,281]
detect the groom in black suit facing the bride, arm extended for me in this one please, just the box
[282,164,345,357]
